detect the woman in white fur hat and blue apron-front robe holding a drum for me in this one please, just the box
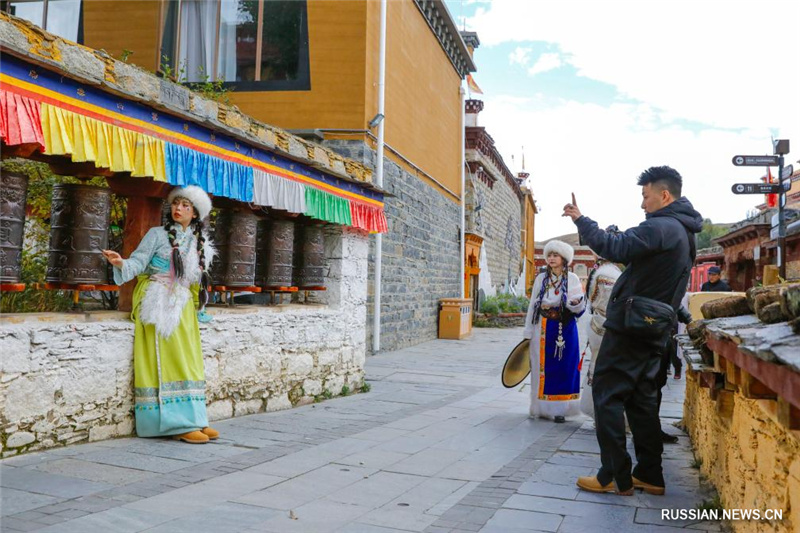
[524,240,586,422]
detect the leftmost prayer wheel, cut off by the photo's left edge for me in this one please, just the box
[0,170,28,283]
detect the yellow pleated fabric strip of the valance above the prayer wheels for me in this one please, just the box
[41,103,167,182]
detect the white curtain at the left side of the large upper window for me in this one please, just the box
[176,0,219,81]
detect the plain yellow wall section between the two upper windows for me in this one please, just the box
[83,0,159,71]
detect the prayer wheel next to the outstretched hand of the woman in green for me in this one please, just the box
[45,183,111,285]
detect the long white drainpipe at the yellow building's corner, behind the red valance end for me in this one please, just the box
[372,0,387,354]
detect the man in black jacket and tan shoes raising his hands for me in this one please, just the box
[564,166,703,495]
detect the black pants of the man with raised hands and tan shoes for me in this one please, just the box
[592,330,666,491]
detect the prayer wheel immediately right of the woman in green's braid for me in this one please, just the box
[211,209,258,287]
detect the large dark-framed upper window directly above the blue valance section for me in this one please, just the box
[160,0,310,91]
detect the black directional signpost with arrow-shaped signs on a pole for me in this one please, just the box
[731,143,794,279]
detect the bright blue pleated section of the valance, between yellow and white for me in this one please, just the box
[166,143,253,202]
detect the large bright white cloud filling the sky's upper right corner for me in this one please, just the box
[467,0,800,131]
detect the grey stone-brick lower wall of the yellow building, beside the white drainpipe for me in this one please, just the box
[324,140,462,351]
